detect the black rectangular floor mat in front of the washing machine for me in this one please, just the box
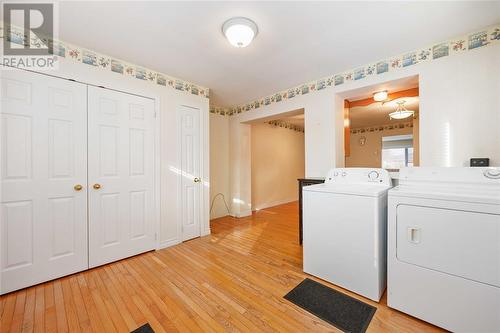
[285,279,377,333]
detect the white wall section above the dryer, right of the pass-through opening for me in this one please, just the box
[420,44,500,166]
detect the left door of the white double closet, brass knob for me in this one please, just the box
[0,70,88,293]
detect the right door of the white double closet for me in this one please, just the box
[88,86,156,267]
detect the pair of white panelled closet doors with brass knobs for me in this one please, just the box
[0,70,156,294]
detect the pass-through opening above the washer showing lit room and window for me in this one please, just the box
[344,79,420,172]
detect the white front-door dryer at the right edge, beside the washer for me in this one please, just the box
[387,168,500,333]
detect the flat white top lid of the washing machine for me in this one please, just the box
[302,183,391,197]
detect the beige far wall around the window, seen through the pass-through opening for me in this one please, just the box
[345,127,413,168]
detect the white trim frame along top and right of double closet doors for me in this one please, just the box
[0,67,162,252]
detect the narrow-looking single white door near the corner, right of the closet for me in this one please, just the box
[179,106,203,241]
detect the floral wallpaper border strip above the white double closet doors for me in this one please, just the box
[0,21,209,98]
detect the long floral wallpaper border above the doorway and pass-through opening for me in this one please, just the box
[210,24,500,116]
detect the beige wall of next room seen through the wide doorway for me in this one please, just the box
[251,123,305,210]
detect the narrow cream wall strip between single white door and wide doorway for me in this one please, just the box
[210,114,231,219]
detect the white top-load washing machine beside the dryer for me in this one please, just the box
[302,168,391,302]
